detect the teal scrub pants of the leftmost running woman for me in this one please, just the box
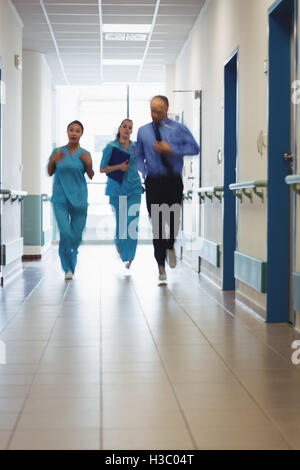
[53,203,87,273]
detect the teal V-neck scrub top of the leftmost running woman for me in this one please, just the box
[50,145,90,209]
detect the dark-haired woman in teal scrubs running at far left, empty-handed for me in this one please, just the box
[48,121,94,280]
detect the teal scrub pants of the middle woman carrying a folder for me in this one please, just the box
[109,195,141,261]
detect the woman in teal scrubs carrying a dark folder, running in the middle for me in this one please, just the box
[100,119,143,269]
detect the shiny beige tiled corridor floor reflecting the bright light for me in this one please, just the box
[0,246,300,450]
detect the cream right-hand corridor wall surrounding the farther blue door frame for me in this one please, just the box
[175,0,273,317]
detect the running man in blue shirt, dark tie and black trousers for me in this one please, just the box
[136,95,199,281]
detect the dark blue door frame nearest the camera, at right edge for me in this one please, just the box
[266,0,294,323]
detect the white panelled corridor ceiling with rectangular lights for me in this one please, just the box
[12,0,205,85]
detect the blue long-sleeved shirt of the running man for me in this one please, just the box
[135,118,199,177]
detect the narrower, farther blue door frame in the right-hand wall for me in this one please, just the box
[222,49,238,290]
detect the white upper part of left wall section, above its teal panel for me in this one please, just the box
[22,51,52,194]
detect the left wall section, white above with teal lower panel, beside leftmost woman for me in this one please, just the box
[22,50,53,260]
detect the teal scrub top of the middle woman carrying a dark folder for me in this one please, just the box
[100,139,143,197]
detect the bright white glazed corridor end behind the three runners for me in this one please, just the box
[56,83,163,244]
